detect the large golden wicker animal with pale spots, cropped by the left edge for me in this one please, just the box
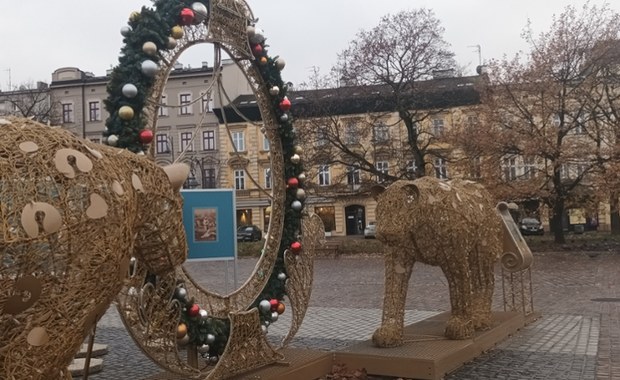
[0,118,189,379]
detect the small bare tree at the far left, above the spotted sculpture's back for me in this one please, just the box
[0,82,59,124]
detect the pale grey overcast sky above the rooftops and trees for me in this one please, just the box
[0,0,620,90]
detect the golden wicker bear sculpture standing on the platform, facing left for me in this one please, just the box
[372,177,502,347]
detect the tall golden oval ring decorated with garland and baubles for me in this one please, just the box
[104,0,322,378]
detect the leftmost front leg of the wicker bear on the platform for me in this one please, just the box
[372,247,415,347]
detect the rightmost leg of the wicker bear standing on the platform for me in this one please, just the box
[470,251,495,330]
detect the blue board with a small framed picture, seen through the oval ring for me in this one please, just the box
[181,189,237,261]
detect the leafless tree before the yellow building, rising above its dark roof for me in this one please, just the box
[298,9,456,181]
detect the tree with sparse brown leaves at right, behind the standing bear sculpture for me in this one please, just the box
[470,3,620,243]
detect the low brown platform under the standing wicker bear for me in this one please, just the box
[149,312,531,380]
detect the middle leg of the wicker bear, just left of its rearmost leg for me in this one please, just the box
[441,256,474,339]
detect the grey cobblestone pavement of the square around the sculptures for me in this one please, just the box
[89,252,620,380]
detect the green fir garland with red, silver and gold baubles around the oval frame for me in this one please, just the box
[103,0,305,361]
